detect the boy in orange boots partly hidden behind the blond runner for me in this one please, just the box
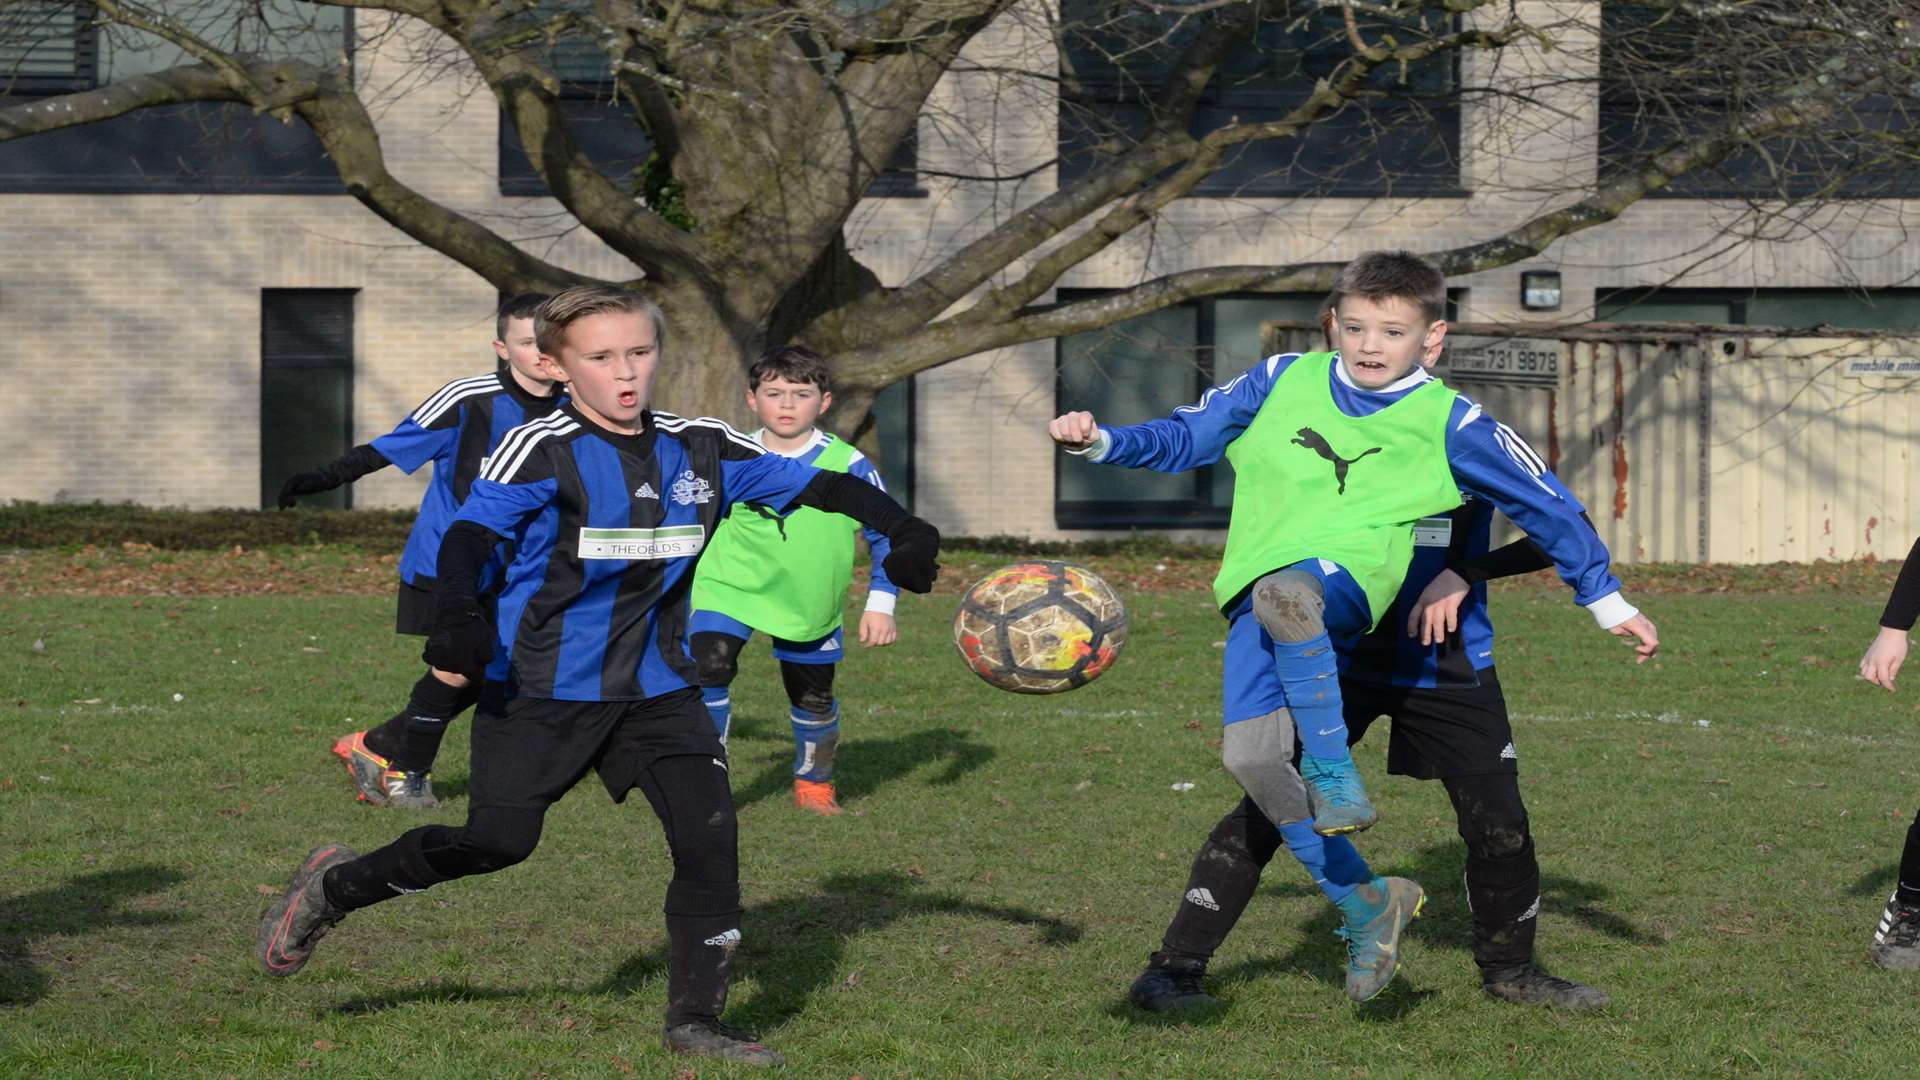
[280,292,561,809]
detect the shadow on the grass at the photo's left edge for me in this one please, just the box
[0,867,186,1007]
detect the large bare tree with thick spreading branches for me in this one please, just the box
[0,0,1920,427]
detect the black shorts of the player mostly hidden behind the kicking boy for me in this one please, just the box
[1340,669,1519,780]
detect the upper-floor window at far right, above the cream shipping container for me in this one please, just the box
[1599,4,1920,200]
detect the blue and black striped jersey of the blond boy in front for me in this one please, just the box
[455,405,818,701]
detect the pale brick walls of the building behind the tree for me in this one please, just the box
[0,0,1920,553]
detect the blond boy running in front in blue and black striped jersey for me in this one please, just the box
[257,286,939,1065]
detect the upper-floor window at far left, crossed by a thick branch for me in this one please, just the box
[0,0,351,194]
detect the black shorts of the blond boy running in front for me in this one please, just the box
[468,682,726,813]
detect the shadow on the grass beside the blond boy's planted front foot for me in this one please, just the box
[603,872,1081,1032]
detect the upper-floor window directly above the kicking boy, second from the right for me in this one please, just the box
[1060,0,1463,198]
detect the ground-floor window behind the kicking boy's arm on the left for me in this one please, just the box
[1054,290,1325,528]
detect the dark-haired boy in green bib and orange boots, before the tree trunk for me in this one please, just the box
[687,346,900,815]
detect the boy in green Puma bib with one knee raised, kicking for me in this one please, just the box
[1048,252,1659,1001]
